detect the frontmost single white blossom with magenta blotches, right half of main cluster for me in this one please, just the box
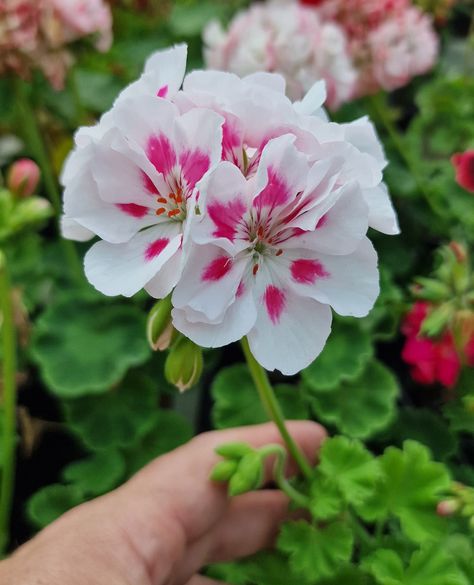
[173,135,378,374]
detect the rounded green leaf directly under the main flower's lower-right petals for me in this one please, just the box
[301,322,373,392]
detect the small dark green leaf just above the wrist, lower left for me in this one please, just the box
[26,483,85,528]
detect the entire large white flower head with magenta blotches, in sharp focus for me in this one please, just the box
[63,45,398,374]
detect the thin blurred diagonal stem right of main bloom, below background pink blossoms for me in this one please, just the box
[369,93,443,215]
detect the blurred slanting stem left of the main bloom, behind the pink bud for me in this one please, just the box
[13,78,83,282]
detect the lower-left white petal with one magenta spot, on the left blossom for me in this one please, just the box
[84,222,181,297]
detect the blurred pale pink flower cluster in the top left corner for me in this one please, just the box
[0,0,112,89]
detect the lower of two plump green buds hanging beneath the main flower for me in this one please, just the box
[165,337,203,392]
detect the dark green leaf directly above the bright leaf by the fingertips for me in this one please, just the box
[311,361,399,439]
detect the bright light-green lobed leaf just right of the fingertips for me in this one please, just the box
[319,437,380,505]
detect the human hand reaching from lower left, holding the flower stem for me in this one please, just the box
[0,421,325,585]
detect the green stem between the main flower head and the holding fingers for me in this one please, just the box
[241,337,312,478]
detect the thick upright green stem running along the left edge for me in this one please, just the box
[0,251,16,554]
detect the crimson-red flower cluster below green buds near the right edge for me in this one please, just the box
[402,301,474,388]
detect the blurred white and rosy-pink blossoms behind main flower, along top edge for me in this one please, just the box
[204,0,438,109]
